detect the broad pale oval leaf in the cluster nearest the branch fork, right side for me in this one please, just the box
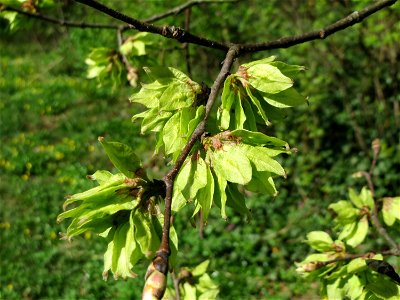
[247,63,293,94]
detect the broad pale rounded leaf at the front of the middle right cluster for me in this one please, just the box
[212,144,252,184]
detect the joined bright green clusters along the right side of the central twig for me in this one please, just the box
[172,57,306,221]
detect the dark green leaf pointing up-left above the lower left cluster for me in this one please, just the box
[99,137,141,178]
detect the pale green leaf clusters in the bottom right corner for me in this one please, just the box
[297,188,400,300]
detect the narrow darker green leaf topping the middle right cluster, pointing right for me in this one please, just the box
[231,129,289,148]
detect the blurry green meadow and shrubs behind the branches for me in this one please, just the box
[0,0,400,299]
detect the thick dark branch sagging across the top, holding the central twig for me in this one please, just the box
[75,0,397,55]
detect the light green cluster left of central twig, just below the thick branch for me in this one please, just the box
[130,67,205,160]
